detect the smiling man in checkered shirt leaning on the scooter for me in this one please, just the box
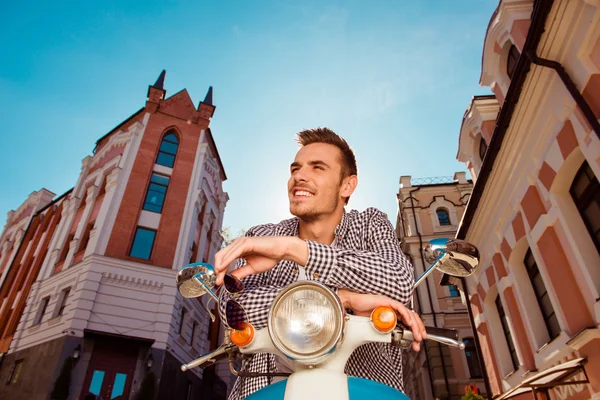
[215,128,425,399]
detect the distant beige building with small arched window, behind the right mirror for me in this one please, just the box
[396,172,485,400]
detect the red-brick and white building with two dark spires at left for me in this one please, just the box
[0,71,228,400]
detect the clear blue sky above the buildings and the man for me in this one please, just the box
[0,0,497,233]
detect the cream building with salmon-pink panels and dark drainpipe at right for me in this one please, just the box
[457,0,600,400]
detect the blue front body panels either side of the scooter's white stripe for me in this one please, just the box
[246,376,410,400]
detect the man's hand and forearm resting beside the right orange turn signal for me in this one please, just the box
[338,289,427,351]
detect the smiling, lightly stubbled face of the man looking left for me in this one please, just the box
[288,143,344,221]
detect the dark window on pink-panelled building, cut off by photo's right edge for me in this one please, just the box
[569,162,600,253]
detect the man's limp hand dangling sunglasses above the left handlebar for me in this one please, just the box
[215,236,308,285]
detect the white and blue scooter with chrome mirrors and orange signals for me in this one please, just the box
[176,238,479,400]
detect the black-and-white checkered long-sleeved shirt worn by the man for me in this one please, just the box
[219,208,414,400]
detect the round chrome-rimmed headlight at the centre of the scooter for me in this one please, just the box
[268,281,345,363]
